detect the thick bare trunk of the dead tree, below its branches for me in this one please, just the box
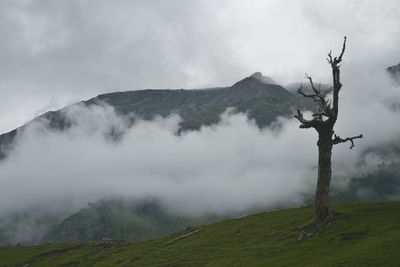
[314,129,332,223]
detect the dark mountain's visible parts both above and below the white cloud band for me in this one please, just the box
[0,72,312,244]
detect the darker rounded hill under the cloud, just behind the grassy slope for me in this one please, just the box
[41,199,216,243]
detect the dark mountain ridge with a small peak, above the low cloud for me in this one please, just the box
[0,73,313,159]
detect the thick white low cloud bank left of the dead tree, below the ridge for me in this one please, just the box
[0,105,315,218]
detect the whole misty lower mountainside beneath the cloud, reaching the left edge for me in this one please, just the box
[0,198,220,247]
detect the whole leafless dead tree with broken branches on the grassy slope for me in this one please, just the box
[295,36,363,224]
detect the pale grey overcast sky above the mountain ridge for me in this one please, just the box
[0,0,400,132]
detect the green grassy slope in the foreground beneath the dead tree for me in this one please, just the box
[0,202,400,267]
